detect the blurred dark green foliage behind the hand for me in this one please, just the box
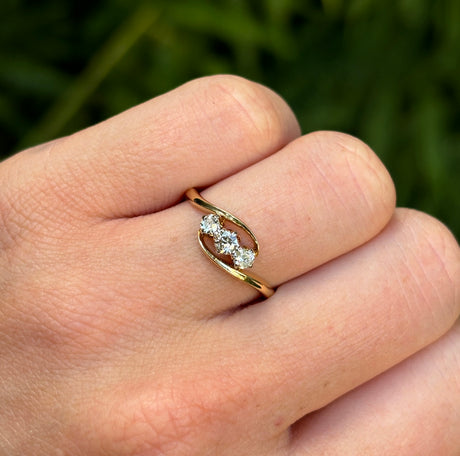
[0,0,460,237]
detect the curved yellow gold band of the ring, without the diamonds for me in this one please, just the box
[185,188,275,298]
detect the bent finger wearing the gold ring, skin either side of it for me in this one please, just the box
[109,132,394,318]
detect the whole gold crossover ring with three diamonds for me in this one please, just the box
[185,188,275,298]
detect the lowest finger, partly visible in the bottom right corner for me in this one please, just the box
[292,323,460,456]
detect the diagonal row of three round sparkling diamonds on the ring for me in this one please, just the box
[200,214,256,269]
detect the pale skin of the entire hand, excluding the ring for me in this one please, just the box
[0,76,460,456]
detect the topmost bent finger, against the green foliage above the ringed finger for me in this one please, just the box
[0,76,299,217]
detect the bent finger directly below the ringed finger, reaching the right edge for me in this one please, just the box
[224,210,460,426]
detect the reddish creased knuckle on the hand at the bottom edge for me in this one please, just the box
[90,373,252,456]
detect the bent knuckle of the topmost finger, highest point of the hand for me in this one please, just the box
[190,75,299,146]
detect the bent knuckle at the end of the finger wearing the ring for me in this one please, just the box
[290,131,396,233]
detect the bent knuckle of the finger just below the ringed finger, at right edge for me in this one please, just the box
[399,209,460,333]
